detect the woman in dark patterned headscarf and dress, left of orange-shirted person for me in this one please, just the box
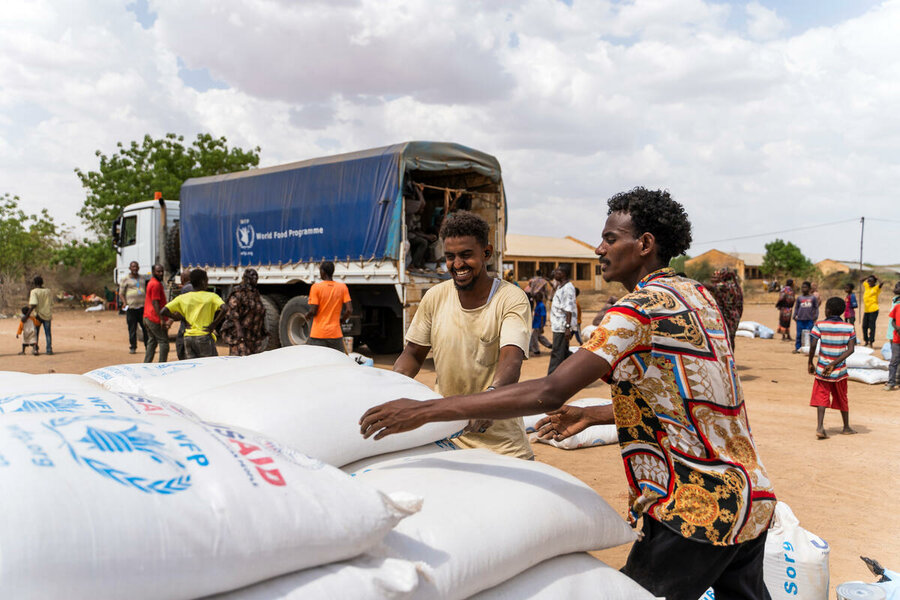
[222,269,268,356]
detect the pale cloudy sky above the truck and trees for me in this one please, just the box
[0,0,900,264]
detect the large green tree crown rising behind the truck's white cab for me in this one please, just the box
[75,133,260,237]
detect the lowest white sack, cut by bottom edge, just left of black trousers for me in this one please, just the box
[471,553,654,600]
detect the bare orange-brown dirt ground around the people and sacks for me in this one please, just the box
[0,294,900,596]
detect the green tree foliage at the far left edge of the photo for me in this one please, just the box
[0,193,65,281]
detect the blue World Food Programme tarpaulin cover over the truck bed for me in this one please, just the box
[180,142,500,267]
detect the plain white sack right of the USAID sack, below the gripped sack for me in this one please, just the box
[356,449,635,600]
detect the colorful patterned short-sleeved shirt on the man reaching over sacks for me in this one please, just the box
[583,268,775,546]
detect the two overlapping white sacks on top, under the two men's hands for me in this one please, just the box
[88,346,465,467]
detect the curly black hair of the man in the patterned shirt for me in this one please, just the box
[606,187,692,265]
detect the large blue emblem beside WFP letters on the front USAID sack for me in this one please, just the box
[44,415,192,495]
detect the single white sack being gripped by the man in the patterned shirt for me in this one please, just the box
[179,364,466,467]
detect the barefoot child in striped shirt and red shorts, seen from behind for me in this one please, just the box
[808,296,856,440]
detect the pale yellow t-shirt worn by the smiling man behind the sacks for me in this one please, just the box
[406,280,534,459]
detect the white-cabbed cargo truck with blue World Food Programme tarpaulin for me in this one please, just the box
[113,142,507,353]
